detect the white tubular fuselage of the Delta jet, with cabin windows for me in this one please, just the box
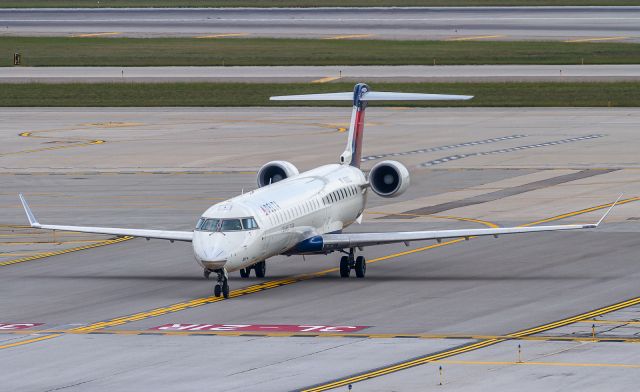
[193,164,367,272]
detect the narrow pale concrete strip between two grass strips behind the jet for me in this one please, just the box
[0,64,640,83]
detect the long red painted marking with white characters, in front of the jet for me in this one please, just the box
[150,324,369,333]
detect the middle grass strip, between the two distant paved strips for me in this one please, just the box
[5,37,640,66]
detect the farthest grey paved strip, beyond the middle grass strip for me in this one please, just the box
[0,7,640,42]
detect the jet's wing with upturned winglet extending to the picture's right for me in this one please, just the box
[320,195,622,250]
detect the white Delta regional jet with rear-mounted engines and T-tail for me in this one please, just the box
[20,84,615,298]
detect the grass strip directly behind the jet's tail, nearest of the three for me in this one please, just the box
[0,82,640,107]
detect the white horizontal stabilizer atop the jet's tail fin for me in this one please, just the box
[270,91,473,101]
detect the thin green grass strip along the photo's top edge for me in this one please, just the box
[5,0,640,8]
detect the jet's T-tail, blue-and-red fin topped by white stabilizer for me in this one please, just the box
[271,83,473,167]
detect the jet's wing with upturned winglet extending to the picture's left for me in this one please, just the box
[18,194,193,242]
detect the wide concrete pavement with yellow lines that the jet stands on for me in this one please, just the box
[0,107,640,391]
